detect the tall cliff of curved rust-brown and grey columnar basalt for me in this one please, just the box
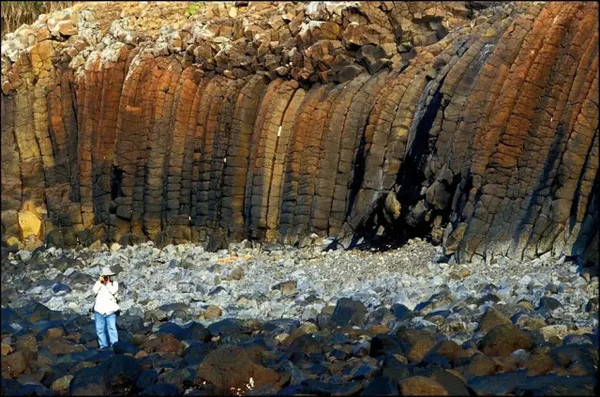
[1,2,600,261]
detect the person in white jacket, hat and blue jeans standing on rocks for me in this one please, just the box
[93,266,119,349]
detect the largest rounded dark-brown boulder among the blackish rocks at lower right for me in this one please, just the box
[482,324,534,357]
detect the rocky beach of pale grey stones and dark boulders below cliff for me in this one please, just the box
[2,239,598,395]
